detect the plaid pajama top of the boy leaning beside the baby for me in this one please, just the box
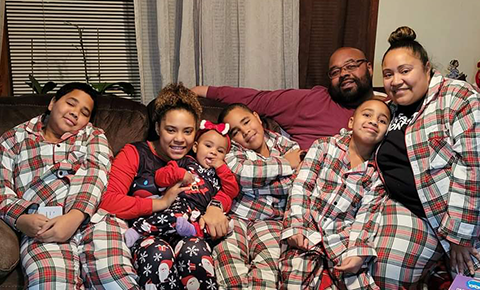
[225,130,300,220]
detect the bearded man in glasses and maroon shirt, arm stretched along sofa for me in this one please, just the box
[192,47,374,150]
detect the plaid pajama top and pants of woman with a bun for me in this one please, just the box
[374,72,480,289]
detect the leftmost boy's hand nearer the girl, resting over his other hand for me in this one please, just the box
[36,209,85,243]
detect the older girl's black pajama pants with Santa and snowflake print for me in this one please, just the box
[132,236,217,290]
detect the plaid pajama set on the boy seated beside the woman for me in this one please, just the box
[280,130,385,289]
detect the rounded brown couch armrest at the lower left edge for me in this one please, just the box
[0,220,20,278]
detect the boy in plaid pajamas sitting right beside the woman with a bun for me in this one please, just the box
[280,99,390,289]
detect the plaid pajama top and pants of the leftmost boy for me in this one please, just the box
[0,115,138,289]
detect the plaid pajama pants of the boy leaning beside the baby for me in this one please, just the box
[212,217,283,289]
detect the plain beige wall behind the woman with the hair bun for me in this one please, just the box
[373,0,480,86]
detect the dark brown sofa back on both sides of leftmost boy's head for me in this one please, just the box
[0,95,149,154]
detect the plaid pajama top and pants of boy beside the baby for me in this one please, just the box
[213,130,299,289]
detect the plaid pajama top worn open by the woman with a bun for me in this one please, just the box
[384,71,480,253]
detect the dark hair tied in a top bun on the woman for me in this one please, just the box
[382,26,428,67]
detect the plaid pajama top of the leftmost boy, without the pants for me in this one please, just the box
[0,115,112,226]
